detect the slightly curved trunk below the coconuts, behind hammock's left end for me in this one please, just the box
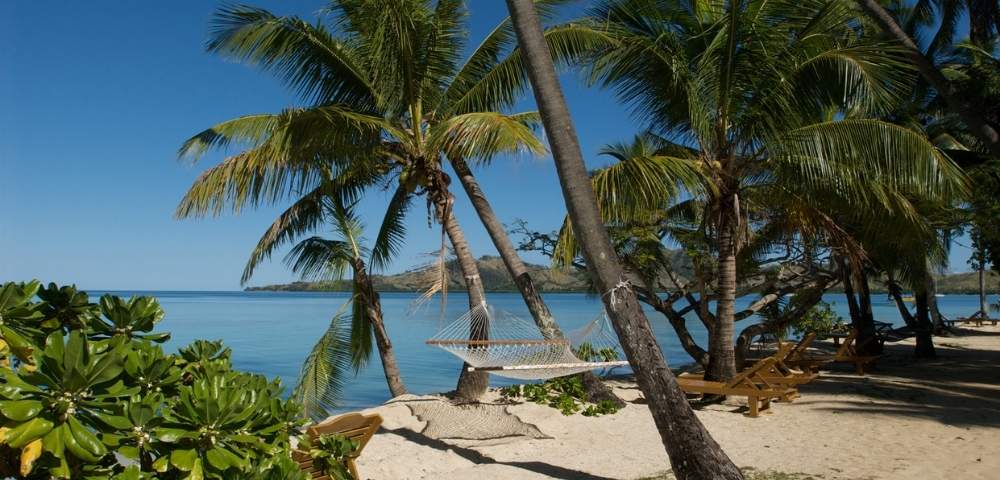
[438,199,490,401]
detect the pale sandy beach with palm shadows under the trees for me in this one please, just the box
[348,327,1000,480]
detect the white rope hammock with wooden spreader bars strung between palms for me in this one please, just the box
[427,302,628,380]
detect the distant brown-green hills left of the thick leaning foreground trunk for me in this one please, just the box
[247,257,588,292]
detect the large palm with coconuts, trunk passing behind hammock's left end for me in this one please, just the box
[178,0,604,399]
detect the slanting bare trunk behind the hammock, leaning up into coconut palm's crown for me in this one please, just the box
[449,156,625,406]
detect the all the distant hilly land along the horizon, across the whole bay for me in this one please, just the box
[246,251,1000,295]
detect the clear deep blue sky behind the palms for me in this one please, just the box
[0,0,968,290]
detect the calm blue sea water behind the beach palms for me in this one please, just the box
[90,291,996,410]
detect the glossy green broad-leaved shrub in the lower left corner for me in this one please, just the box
[0,282,312,480]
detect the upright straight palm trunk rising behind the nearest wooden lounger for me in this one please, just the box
[706,202,736,382]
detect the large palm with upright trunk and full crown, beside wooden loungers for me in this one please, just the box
[574,0,962,379]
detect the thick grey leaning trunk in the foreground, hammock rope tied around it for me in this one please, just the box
[507,0,743,474]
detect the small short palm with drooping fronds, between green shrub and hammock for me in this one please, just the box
[278,197,406,419]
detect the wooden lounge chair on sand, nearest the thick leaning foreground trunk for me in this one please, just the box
[677,357,795,417]
